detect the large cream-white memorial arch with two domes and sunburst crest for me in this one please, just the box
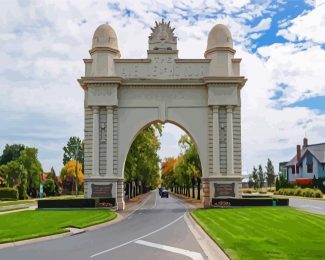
[79,21,246,209]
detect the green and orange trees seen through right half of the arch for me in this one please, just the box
[161,135,202,199]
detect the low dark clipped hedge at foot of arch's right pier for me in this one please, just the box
[212,198,289,207]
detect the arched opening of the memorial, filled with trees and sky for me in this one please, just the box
[122,120,202,201]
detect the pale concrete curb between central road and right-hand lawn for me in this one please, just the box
[184,212,229,260]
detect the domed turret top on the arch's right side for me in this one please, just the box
[206,24,233,52]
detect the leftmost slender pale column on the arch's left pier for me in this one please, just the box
[92,106,99,176]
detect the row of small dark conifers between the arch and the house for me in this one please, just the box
[248,159,275,189]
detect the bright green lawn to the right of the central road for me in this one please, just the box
[191,207,325,259]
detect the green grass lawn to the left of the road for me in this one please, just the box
[0,210,116,243]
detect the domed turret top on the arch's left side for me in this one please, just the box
[92,24,118,50]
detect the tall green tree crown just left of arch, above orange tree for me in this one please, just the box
[63,136,84,165]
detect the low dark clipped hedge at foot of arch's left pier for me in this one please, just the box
[37,198,116,209]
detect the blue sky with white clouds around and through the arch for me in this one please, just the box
[0,0,325,174]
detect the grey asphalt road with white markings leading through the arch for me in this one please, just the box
[0,191,207,260]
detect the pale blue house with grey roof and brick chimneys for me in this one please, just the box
[286,138,325,184]
